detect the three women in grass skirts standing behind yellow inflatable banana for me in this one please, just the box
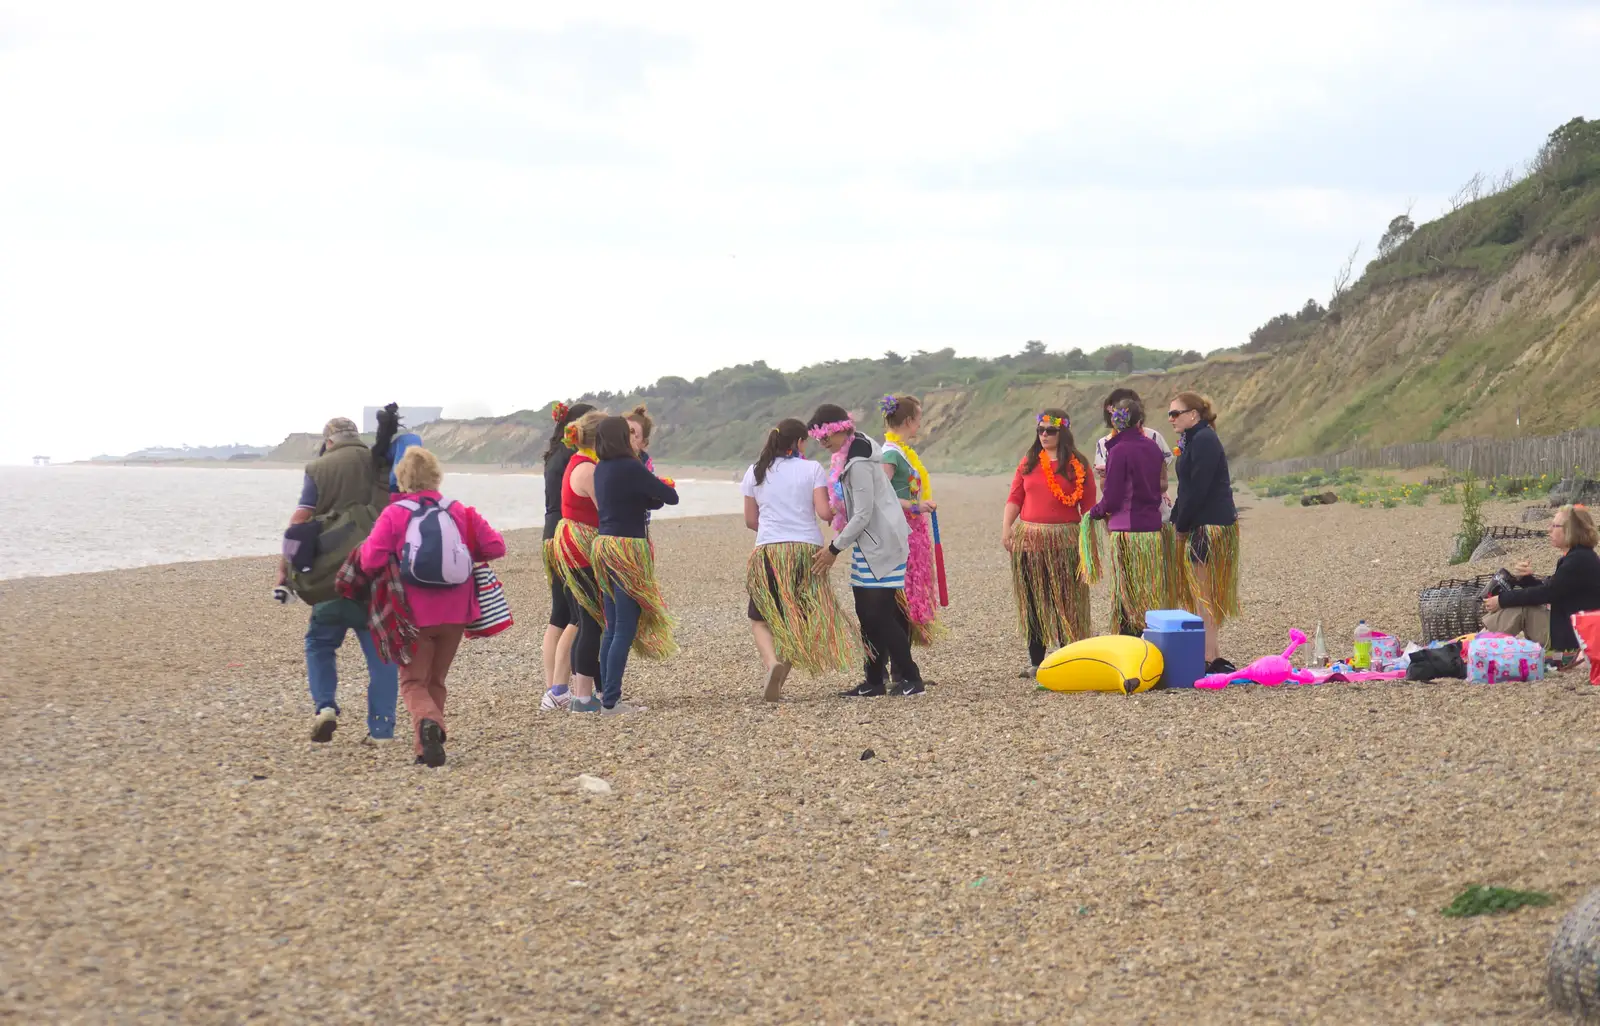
[1000,389,1240,677]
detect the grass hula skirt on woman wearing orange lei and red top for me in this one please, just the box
[1011,520,1093,648]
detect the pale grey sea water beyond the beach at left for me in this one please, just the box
[0,466,742,579]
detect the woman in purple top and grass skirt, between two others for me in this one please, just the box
[1085,399,1170,637]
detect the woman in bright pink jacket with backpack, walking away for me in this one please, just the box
[360,447,506,767]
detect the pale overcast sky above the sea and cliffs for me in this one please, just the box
[0,0,1600,463]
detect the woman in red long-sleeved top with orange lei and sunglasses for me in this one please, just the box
[1000,410,1094,677]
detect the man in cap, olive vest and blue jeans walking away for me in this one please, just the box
[274,416,398,744]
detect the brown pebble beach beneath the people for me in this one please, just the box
[0,475,1600,1024]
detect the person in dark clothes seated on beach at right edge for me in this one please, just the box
[1483,506,1600,665]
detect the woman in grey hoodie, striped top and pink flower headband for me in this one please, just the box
[808,403,926,698]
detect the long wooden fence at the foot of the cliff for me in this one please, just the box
[1229,427,1600,480]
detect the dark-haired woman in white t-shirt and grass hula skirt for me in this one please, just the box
[739,418,859,701]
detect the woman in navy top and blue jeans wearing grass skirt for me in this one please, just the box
[595,416,678,712]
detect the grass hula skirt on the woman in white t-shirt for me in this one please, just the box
[744,541,861,674]
